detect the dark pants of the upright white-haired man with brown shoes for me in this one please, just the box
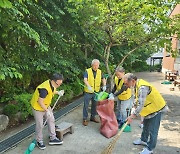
[83,93,97,120]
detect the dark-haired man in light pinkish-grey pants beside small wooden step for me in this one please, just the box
[31,73,64,150]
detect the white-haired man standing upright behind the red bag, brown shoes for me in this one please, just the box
[83,59,106,126]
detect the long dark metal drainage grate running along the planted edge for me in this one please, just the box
[0,97,83,153]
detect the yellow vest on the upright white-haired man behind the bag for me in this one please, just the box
[84,68,101,93]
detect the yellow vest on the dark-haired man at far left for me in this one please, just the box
[31,80,56,111]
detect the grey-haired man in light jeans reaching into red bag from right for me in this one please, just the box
[110,67,133,128]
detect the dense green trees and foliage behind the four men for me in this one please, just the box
[0,0,180,122]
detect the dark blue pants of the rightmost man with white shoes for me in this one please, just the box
[141,112,161,151]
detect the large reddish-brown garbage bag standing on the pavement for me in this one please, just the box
[96,99,118,138]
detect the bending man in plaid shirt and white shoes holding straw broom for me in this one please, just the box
[124,73,167,154]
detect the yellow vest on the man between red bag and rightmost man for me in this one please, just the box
[115,76,132,101]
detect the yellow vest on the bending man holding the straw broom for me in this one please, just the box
[135,79,166,117]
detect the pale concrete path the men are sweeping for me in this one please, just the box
[2,73,180,154]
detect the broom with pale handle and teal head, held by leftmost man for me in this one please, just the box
[24,96,61,154]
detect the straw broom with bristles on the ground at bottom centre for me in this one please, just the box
[101,122,128,154]
